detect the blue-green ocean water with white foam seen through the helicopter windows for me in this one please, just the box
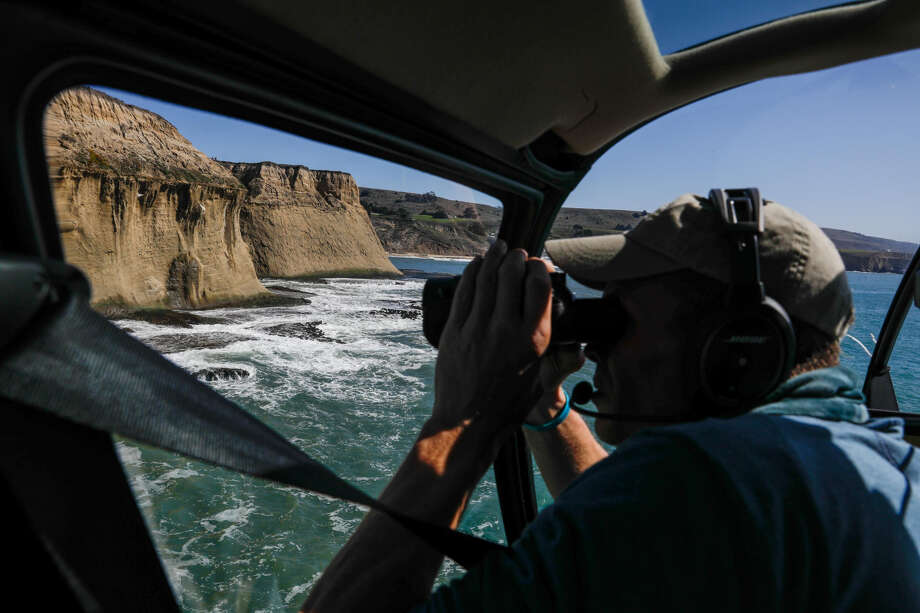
[117,258,920,612]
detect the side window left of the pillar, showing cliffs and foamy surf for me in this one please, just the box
[45,87,503,611]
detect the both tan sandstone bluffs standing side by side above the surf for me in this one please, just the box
[45,88,399,308]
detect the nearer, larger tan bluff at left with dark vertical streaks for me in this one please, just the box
[45,88,268,308]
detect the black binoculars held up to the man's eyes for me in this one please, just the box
[422,272,627,347]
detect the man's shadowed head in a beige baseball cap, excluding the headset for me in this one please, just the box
[546,195,853,442]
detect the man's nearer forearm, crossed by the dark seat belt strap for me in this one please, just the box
[303,414,504,612]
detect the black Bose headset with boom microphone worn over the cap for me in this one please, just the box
[572,188,795,423]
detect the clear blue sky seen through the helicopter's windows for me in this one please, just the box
[100,0,920,242]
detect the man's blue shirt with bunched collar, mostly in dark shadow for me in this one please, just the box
[417,368,920,613]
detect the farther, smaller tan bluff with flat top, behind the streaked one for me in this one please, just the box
[221,162,400,278]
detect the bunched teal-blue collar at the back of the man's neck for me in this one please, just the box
[751,366,869,424]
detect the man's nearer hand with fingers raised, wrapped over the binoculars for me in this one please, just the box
[432,241,551,434]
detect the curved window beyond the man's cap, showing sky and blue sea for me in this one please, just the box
[550,49,920,426]
